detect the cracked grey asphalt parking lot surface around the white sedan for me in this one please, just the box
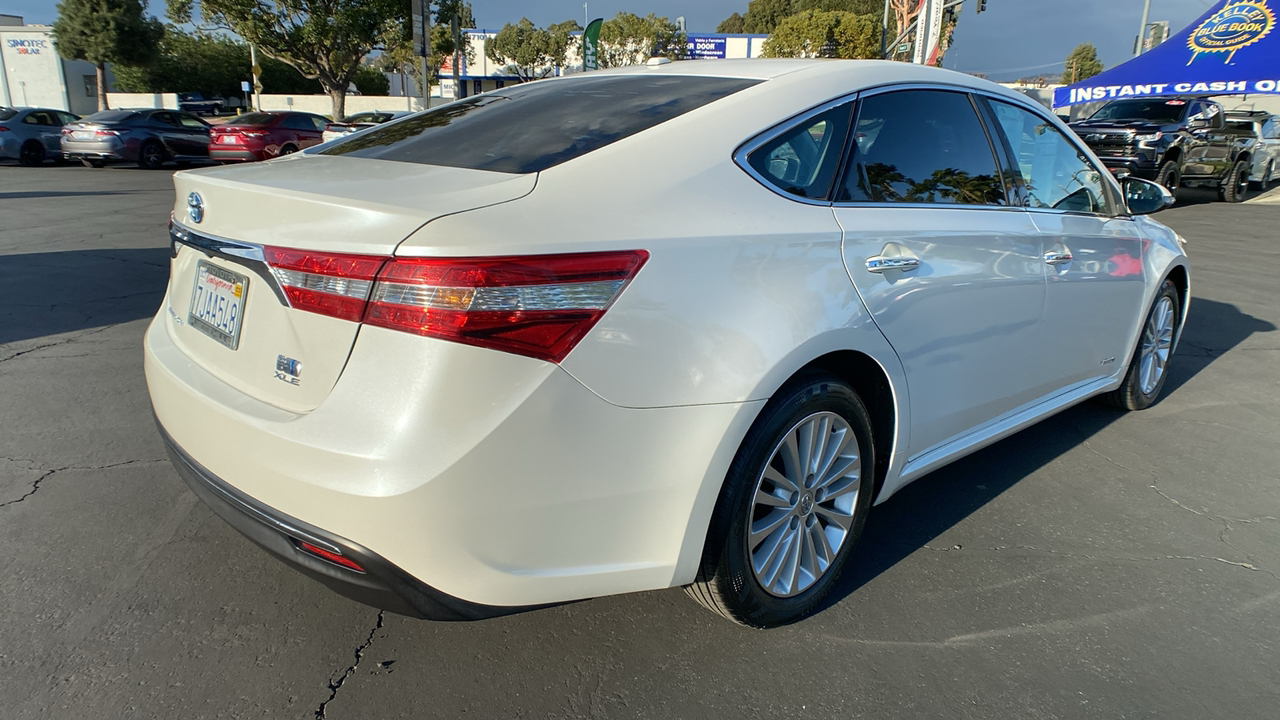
[0,165,1280,720]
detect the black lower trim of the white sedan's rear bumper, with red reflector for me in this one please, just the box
[156,420,540,620]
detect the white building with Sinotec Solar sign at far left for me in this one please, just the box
[0,15,97,115]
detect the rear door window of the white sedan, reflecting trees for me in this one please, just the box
[836,90,1006,205]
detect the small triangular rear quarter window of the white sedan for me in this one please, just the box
[748,102,852,197]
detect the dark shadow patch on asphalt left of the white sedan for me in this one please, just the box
[0,247,169,345]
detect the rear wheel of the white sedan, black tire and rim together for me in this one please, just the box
[686,372,876,628]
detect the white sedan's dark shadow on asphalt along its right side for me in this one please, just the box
[817,297,1276,612]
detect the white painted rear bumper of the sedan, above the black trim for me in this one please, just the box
[145,304,763,607]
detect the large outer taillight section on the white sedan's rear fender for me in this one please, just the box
[365,250,649,363]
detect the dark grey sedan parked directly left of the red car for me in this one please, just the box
[61,108,210,170]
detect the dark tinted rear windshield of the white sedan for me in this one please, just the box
[320,76,759,173]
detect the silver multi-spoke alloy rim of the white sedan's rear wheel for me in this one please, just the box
[746,413,863,597]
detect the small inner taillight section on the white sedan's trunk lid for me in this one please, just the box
[262,247,387,322]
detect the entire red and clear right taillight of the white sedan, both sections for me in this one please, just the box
[262,247,649,363]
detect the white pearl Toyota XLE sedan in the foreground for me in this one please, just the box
[146,60,1190,626]
